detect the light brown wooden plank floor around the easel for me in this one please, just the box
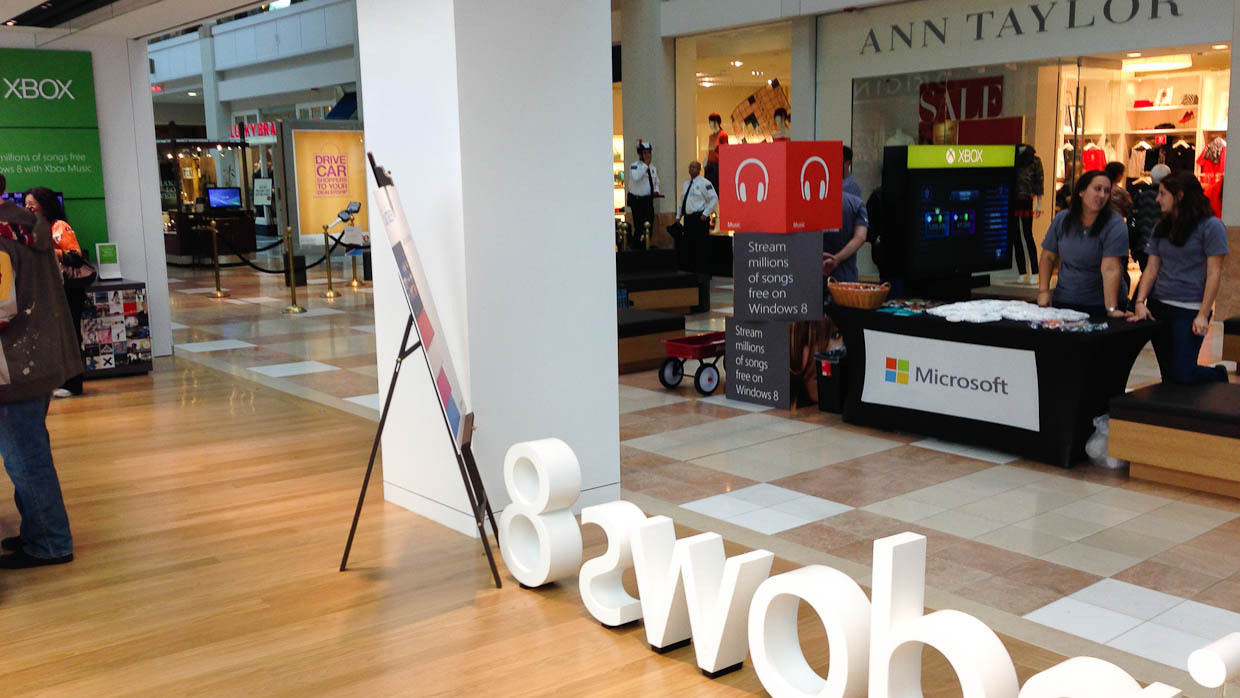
[0,360,1060,697]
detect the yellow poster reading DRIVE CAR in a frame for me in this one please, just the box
[293,130,370,236]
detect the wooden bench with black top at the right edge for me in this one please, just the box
[1109,383,1240,497]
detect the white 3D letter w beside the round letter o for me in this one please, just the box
[632,516,775,673]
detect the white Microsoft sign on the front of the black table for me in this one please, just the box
[861,330,1040,431]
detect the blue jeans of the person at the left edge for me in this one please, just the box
[0,395,73,558]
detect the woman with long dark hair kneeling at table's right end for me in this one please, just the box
[1132,171,1228,383]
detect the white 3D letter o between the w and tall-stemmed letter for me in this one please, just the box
[749,565,869,698]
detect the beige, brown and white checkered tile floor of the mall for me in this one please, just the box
[170,264,1240,667]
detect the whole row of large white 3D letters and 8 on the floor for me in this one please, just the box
[498,438,1240,698]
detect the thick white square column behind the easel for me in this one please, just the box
[357,0,620,533]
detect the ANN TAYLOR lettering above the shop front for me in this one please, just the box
[861,0,1197,56]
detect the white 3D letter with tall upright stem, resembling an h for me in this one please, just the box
[869,533,1019,698]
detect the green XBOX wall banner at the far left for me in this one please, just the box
[0,48,108,257]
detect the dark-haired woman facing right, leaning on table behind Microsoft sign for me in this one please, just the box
[1038,170,1128,317]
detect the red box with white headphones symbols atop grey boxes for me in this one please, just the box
[719,140,843,233]
